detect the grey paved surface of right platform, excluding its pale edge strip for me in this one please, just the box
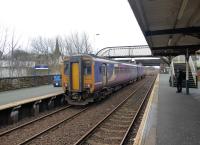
[156,74,200,145]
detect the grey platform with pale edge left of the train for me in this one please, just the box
[0,85,63,110]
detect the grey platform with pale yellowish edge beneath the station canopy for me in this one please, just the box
[135,74,200,145]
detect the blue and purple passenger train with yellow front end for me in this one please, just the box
[61,54,145,105]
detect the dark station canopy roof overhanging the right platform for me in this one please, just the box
[129,0,200,56]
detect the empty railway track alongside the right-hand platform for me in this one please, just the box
[74,76,155,145]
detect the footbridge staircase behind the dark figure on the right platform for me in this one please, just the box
[173,63,198,88]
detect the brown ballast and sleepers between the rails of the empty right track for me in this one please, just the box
[79,77,153,145]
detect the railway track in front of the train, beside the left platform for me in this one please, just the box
[0,105,88,145]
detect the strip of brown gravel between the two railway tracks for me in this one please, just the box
[27,80,147,145]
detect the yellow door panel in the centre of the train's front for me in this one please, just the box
[72,62,79,90]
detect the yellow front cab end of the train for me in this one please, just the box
[63,56,94,105]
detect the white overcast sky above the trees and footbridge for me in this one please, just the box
[0,0,146,52]
